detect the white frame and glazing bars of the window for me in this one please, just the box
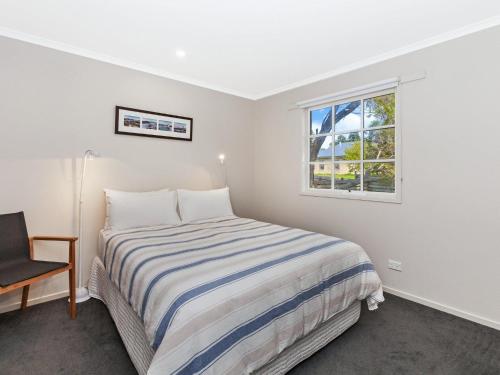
[296,78,403,203]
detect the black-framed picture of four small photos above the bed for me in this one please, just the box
[115,106,193,141]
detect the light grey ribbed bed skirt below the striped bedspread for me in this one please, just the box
[88,257,361,375]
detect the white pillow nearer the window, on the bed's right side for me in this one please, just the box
[177,187,233,223]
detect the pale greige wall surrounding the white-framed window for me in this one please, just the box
[254,27,500,328]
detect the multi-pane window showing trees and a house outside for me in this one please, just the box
[303,85,401,202]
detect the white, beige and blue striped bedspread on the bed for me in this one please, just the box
[101,217,383,375]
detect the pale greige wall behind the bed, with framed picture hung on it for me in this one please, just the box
[0,38,253,311]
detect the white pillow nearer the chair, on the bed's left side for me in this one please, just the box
[104,189,180,230]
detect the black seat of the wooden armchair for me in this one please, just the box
[0,258,68,288]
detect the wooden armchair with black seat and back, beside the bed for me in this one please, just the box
[0,212,78,319]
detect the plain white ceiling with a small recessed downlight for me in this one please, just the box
[0,0,500,99]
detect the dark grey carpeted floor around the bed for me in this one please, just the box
[0,295,500,375]
